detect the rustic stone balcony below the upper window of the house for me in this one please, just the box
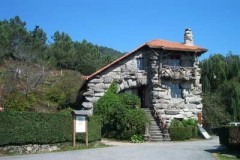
[160,65,195,80]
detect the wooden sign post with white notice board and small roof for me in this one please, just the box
[72,110,89,147]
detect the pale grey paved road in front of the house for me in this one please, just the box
[0,137,219,160]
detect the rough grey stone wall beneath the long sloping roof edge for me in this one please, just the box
[82,51,148,112]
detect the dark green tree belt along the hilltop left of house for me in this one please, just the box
[0,17,122,75]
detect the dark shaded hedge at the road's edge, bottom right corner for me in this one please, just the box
[217,126,240,150]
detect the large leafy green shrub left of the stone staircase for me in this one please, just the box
[94,83,148,140]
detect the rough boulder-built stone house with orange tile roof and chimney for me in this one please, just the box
[79,29,207,139]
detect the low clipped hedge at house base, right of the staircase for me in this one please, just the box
[169,126,193,141]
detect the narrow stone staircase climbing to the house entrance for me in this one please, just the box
[142,108,163,142]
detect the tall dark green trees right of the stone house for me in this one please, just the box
[201,54,240,129]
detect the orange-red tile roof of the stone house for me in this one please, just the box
[85,40,207,80]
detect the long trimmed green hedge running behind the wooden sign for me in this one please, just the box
[0,111,101,146]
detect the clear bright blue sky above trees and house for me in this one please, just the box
[0,0,240,59]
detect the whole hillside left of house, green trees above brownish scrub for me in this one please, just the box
[0,16,122,112]
